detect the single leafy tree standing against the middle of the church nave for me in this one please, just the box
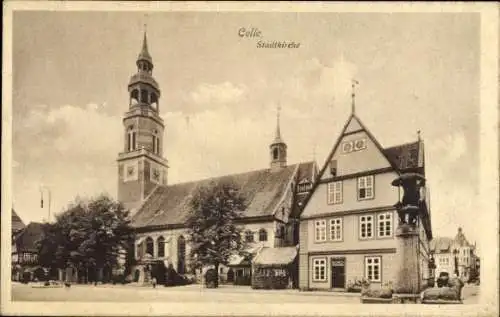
[186,181,248,286]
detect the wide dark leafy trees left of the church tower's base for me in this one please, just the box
[38,195,133,268]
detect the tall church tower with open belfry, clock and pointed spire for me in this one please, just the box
[117,32,168,213]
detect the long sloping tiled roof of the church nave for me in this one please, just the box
[131,162,314,228]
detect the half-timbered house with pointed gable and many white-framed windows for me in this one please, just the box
[299,113,432,290]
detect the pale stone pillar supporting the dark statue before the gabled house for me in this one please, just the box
[394,224,420,294]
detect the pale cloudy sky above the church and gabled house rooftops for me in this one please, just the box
[12,11,481,242]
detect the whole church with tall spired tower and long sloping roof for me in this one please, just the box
[117,34,317,282]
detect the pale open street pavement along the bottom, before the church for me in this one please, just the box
[12,283,479,304]
